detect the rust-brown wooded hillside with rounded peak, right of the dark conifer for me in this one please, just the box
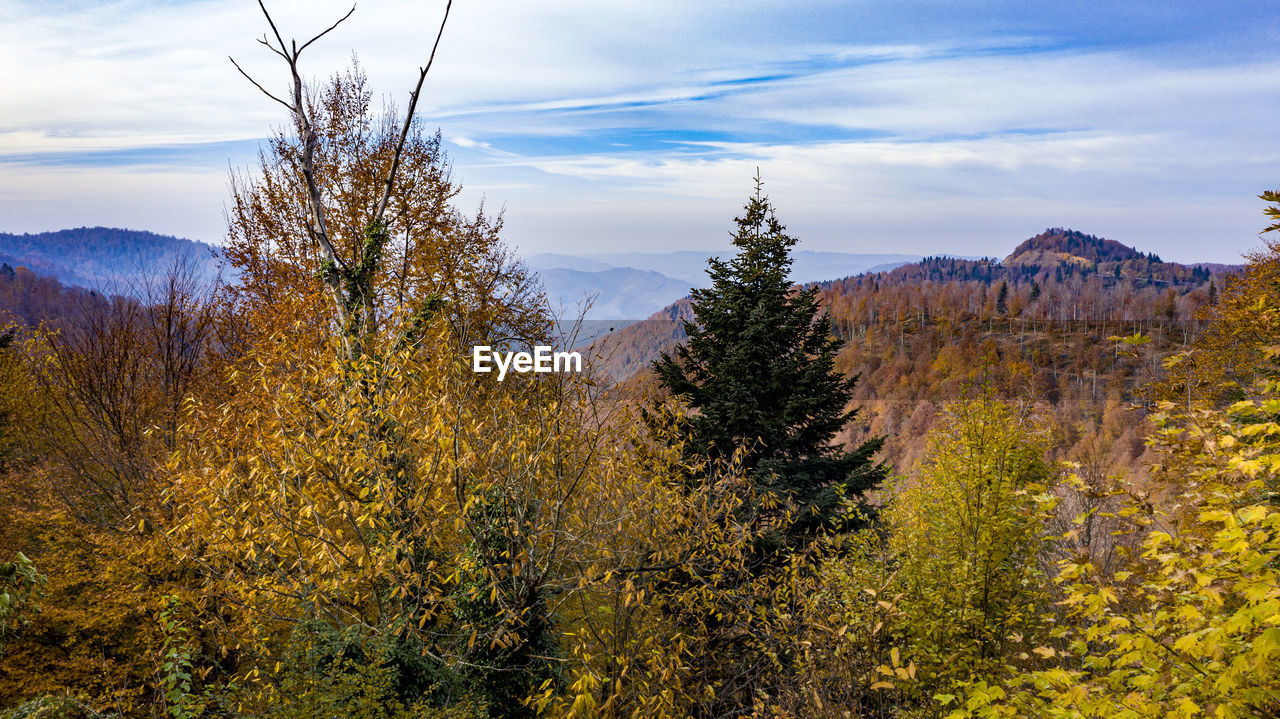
[594,230,1239,471]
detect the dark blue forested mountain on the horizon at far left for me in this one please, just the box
[0,228,219,289]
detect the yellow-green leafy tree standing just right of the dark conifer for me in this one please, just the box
[884,397,1053,701]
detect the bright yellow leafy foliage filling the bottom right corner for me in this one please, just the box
[1008,376,1280,718]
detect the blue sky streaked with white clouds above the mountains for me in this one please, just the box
[0,0,1280,262]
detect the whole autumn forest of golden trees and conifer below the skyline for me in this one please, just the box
[0,5,1280,719]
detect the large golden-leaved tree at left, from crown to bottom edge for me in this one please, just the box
[165,6,672,716]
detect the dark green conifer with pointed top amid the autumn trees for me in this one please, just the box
[653,178,886,539]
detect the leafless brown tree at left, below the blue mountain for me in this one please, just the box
[32,256,215,528]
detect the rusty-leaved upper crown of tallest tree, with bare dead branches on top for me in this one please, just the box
[227,4,549,360]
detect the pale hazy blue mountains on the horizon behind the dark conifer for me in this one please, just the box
[526,249,922,320]
